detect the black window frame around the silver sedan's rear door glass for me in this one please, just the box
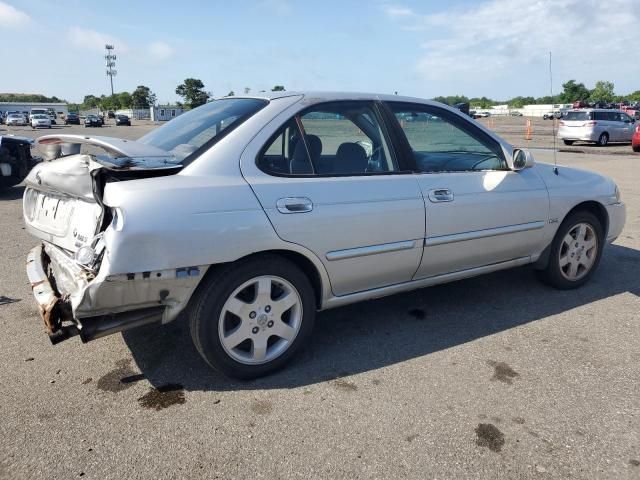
[255,100,414,179]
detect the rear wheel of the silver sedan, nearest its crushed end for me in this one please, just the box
[189,255,316,380]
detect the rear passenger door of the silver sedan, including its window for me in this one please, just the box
[241,101,425,295]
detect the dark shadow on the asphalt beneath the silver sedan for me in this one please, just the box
[123,245,640,391]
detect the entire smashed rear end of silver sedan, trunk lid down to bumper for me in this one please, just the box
[23,135,200,344]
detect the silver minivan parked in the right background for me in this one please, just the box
[558,108,635,146]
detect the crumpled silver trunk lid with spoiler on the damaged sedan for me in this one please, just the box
[23,135,182,253]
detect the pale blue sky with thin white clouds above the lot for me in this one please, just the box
[0,0,640,103]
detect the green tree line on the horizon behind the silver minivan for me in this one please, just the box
[433,80,640,108]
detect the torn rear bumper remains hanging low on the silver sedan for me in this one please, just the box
[27,244,166,345]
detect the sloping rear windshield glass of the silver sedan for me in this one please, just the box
[138,98,268,161]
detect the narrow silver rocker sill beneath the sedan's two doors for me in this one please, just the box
[322,256,532,310]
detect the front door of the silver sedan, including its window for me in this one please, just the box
[382,102,549,278]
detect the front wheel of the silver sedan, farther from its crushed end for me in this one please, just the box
[539,211,604,290]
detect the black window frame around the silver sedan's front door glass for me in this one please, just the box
[382,100,512,175]
